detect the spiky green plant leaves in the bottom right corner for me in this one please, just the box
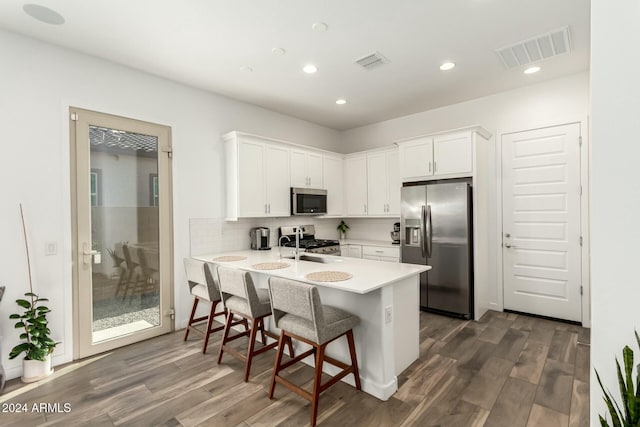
[596,331,640,427]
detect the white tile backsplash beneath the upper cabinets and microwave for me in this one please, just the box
[189,217,400,256]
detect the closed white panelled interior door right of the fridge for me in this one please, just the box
[502,123,582,321]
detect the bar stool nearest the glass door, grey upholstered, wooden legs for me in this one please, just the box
[184,258,225,354]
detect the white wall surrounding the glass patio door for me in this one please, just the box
[0,30,339,377]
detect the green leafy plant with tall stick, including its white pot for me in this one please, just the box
[9,204,58,383]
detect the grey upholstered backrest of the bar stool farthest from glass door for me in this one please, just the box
[269,277,325,342]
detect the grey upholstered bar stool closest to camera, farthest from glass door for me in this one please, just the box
[269,277,362,426]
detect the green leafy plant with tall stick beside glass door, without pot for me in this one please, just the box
[9,203,58,361]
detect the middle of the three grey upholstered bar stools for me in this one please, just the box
[218,266,293,382]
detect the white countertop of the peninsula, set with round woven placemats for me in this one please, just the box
[193,248,431,294]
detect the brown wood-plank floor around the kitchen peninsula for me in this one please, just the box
[0,312,589,427]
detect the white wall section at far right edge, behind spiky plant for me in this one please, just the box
[591,0,640,425]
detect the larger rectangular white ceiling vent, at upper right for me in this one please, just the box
[496,27,571,68]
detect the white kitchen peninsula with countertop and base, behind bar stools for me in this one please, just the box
[194,248,431,400]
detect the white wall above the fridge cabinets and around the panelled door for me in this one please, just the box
[341,71,589,309]
